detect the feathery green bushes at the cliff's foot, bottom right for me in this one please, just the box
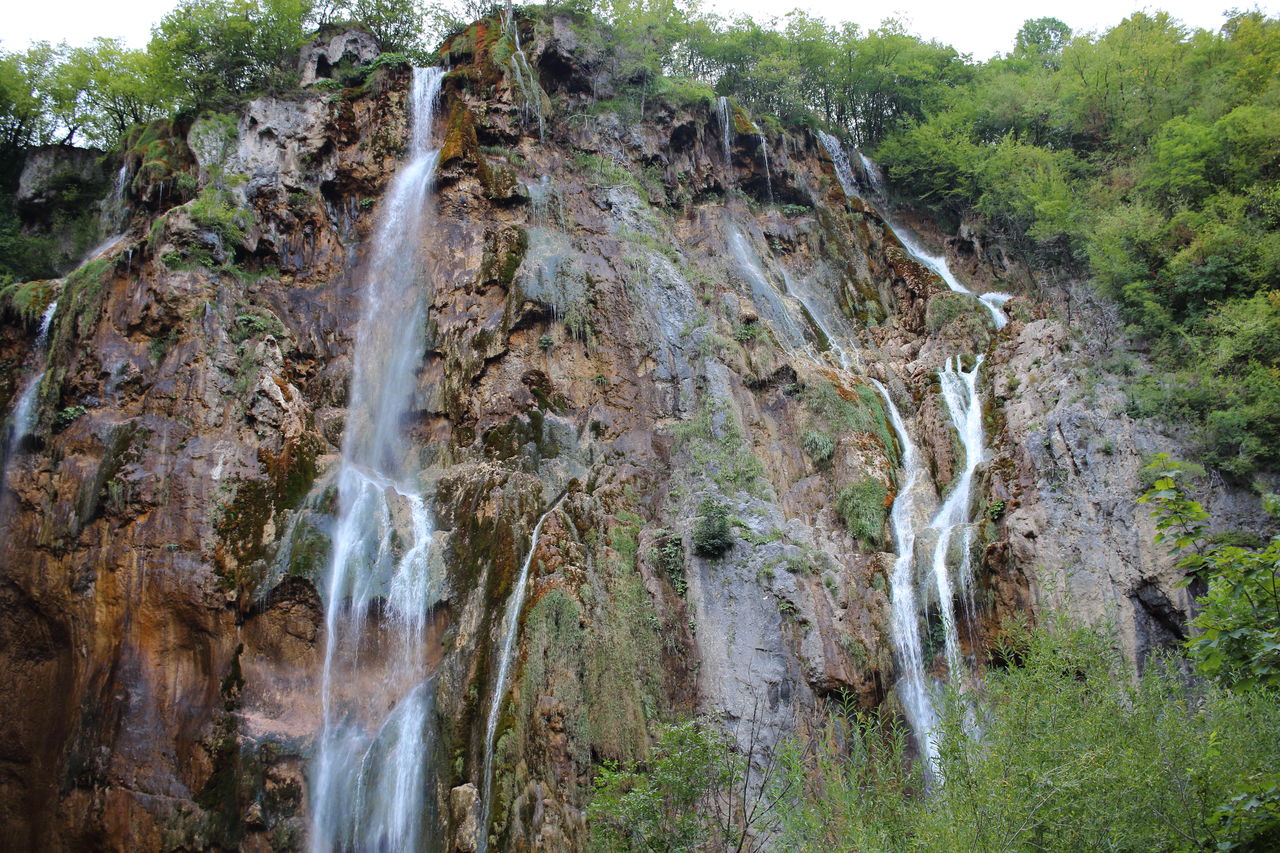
[777,613,1280,853]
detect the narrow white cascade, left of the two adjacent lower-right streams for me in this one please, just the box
[872,379,938,766]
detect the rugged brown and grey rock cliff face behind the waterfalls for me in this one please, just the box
[0,19,1244,850]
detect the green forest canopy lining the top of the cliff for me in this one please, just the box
[0,0,1280,478]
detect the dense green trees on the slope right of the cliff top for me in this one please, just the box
[860,6,1280,478]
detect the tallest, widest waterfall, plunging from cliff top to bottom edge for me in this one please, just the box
[311,68,444,853]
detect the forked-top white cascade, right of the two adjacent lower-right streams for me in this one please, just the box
[929,355,984,678]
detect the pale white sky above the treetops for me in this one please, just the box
[0,0,1280,59]
